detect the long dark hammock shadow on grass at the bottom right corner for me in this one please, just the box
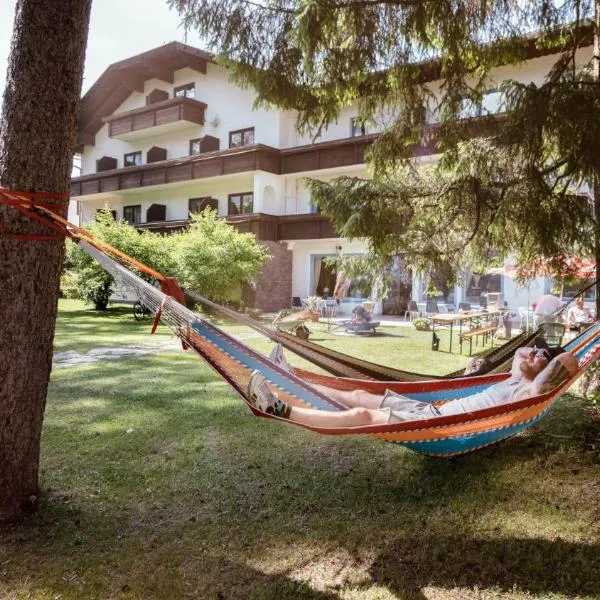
[370,532,600,600]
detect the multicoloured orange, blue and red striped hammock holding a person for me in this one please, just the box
[5,194,600,457]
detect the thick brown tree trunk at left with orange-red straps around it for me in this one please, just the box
[0,0,91,522]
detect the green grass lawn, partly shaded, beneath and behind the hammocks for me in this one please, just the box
[0,302,600,600]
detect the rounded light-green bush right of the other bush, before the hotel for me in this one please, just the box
[172,209,269,301]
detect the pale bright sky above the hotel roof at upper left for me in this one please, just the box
[0,0,202,98]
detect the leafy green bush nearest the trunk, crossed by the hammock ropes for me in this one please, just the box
[66,208,177,310]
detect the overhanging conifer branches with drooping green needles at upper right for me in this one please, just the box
[169,0,600,308]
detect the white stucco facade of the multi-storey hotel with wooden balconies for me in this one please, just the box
[70,42,591,310]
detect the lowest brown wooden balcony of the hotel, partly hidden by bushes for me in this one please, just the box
[135,213,340,242]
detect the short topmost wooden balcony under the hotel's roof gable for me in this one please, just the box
[104,97,206,141]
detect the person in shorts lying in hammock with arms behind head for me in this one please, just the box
[248,347,579,427]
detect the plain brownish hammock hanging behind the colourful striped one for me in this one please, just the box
[184,289,539,381]
